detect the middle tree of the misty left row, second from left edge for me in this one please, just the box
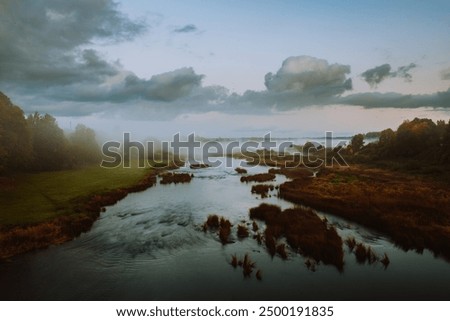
[27,112,70,171]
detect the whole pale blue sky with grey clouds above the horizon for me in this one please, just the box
[0,0,450,139]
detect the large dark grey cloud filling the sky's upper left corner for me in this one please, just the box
[0,0,146,87]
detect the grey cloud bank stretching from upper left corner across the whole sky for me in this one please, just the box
[0,0,450,118]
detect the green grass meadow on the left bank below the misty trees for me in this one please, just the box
[0,165,151,225]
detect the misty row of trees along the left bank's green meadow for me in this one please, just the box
[0,92,101,173]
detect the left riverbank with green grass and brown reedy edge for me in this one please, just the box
[0,165,157,259]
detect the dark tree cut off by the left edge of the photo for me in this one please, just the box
[0,92,32,172]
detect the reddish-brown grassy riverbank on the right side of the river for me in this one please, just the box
[279,165,450,260]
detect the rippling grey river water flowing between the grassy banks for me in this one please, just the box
[0,160,450,300]
